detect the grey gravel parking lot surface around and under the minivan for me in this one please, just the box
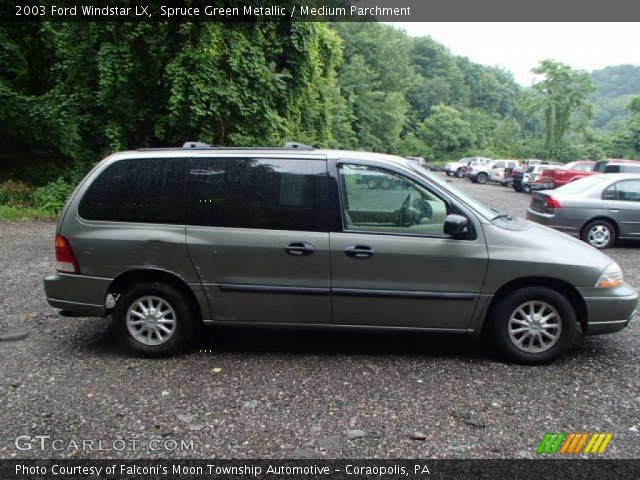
[0,174,640,458]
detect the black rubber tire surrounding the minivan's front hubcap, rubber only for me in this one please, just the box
[484,287,578,365]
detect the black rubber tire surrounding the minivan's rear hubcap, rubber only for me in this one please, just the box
[113,282,201,357]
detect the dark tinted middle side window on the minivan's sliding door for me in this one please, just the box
[188,158,328,232]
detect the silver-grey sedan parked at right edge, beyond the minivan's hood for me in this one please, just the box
[527,173,640,249]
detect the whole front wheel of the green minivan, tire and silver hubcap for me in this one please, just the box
[486,287,578,365]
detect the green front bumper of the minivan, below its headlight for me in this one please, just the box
[578,283,638,335]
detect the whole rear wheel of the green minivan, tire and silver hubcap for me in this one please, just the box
[113,282,197,357]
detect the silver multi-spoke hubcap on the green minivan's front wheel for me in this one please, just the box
[509,300,562,353]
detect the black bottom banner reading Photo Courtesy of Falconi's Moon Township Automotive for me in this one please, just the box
[0,459,640,480]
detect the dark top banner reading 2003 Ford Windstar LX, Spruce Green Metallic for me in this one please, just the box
[0,0,640,21]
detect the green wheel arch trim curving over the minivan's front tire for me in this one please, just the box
[481,277,588,332]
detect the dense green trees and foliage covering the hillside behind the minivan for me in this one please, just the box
[0,22,640,212]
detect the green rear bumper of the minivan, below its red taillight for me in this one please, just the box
[44,273,111,317]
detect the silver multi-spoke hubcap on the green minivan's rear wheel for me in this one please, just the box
[127,296,177,345]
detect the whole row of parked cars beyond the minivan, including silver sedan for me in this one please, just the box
[444,157,640,249]
